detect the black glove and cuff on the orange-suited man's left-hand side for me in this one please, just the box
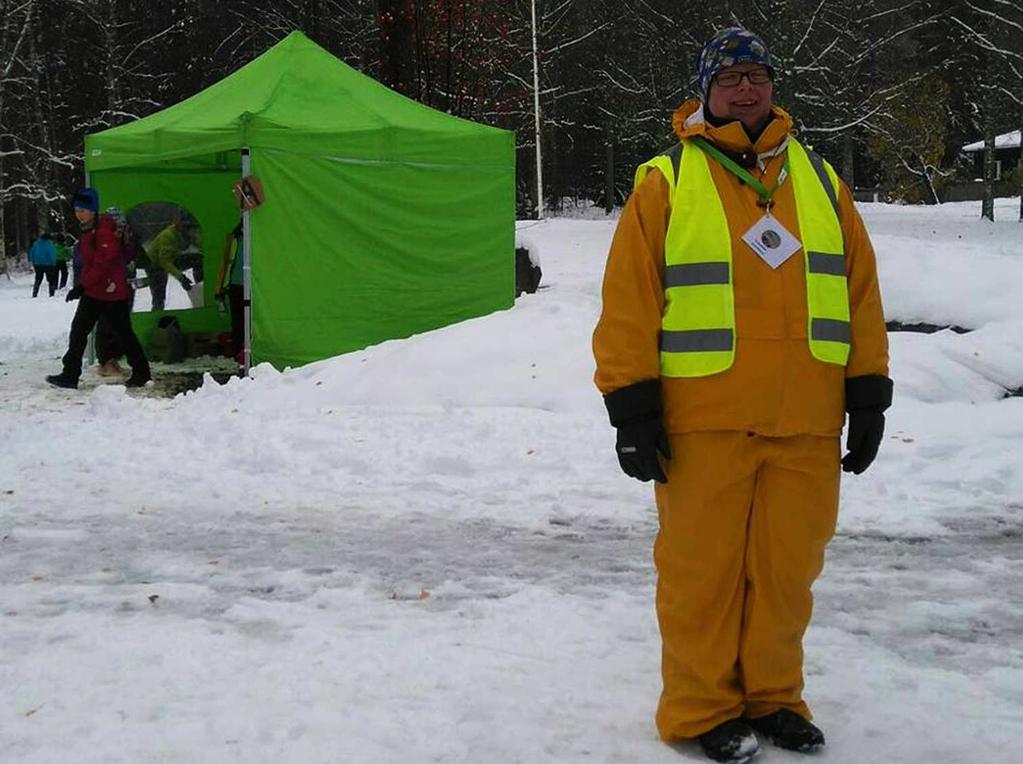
[604,379,671,483]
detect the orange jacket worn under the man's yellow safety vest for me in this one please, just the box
[593,100,888,437]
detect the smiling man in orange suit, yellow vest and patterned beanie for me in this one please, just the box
[593,29,892,762]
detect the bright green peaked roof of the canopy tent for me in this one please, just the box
[86,32,509,172]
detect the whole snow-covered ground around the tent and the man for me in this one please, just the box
[0,200,1023,764]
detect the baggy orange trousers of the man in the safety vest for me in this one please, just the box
[654,432,840,740]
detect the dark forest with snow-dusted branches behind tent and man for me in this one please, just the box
[0,0,1023,262]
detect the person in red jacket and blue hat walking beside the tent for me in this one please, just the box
[46,188,151,389]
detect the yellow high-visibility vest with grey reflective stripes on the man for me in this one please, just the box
[635,139,850,377]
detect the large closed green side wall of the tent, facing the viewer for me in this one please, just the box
[251,145,515,365]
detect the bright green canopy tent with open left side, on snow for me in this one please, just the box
[85,32,515,367]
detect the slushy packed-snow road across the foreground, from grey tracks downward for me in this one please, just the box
[0,492,1023,762]
